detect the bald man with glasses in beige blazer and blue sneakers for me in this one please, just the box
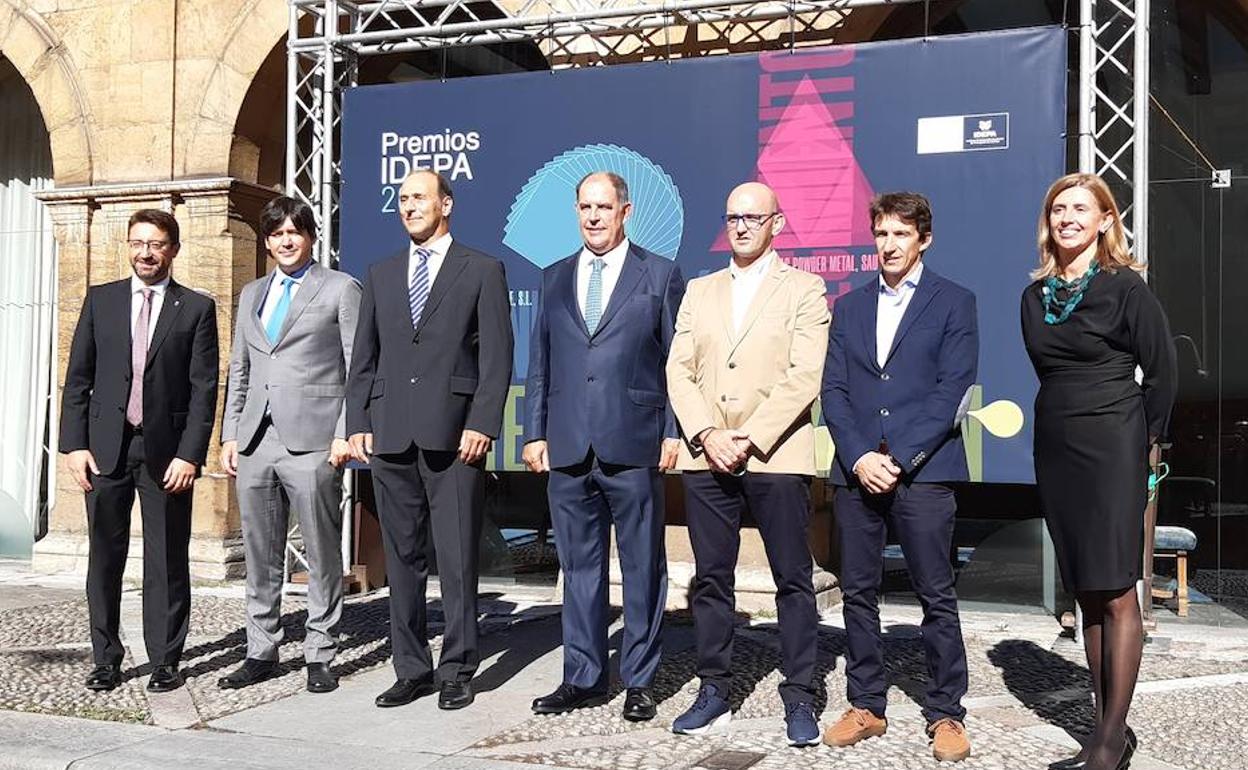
[668,182,829,746]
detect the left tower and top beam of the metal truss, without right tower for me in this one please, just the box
[285,0,930,581]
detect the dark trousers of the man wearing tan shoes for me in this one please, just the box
[834,484,967,724]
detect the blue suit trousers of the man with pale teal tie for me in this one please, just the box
[547,452,668,690]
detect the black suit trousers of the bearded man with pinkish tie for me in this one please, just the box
[86,429,192,665]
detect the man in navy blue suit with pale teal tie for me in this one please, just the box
[524,172,684,721]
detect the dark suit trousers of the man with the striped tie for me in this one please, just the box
[369,446,485,681]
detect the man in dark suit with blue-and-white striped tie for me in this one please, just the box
[347,171,513,709]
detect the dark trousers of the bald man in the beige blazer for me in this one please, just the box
[681,470,819,705]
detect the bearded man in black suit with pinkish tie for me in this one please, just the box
[60,208,217,693]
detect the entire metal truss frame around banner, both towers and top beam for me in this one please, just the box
[286,0,1149,589]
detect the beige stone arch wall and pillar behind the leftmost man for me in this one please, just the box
[0,0,288,579]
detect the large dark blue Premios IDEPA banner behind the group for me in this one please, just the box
[342,27,1066,483]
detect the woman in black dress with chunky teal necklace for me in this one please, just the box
[1022,173,1176,770]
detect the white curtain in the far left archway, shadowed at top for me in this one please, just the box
[0,57,56,558]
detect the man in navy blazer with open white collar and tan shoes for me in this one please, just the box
[822,192,980,761]
